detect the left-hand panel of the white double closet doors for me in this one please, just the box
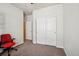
[36,17,46,44]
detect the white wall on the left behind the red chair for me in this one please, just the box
[0,4,23,45]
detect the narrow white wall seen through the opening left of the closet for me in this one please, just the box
[25,15,33,40]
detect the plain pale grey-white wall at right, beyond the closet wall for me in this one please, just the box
[64,3,79,56]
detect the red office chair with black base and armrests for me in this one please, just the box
[0,34,17,56]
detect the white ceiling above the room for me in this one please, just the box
[11,3,58,15]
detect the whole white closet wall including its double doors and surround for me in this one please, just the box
[33,5,63,48]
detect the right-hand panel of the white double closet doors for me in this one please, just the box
[46,17,56,46]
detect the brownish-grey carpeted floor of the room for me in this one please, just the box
[2,40,65,56]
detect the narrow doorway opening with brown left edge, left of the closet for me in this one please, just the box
[24,14,33,42]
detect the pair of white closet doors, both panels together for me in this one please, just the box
[37,17,56,46]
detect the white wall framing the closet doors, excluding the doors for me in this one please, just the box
[33,5,63,48]
